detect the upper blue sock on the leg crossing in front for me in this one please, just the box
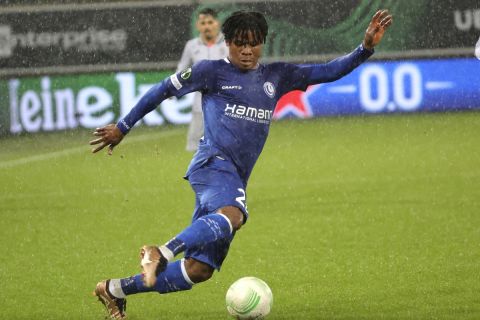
[162,213,233,259]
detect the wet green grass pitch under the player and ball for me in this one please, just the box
[0,112,480,320]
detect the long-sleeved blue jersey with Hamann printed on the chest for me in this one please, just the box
[117,46,373,186]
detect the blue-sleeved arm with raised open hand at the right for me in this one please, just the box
[307,10,393,85]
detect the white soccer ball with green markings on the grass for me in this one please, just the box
[225,277,273,319]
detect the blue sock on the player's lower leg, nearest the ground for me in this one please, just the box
[115,259,194,298]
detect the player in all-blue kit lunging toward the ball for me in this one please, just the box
[90,10,392,319]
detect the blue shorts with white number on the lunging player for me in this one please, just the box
[185,156,248,270]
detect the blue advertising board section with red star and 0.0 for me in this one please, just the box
[274,58,480,119]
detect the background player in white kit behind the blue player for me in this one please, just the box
[177,8,228,151]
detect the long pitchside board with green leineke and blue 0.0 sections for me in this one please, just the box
[0,58,480,135]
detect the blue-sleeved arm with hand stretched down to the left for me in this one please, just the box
[90,60,213,155]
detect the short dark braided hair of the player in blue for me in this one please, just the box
[222,11,268,43]
